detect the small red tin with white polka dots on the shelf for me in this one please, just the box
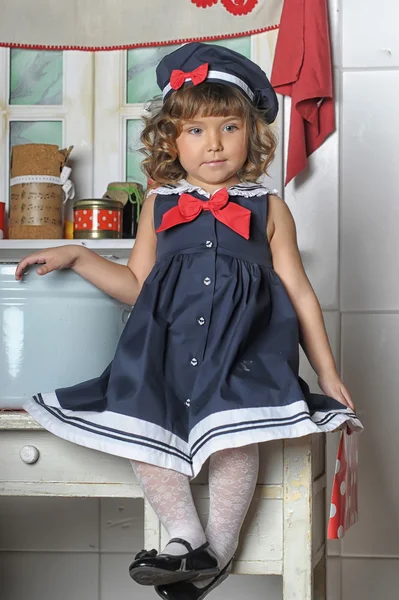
[73,198,123,240]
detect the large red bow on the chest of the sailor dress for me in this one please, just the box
[156,188,251,240]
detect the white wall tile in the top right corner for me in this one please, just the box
[341,0,399,68]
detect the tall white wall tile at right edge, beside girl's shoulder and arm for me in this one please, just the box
[341,71,399,311]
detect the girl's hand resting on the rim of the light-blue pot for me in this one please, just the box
[15,245,82,281]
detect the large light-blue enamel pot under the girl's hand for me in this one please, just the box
[0,263,130,409]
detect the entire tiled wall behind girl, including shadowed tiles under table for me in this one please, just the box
[0,0,399,600]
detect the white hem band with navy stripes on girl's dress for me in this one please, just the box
[24,394,362,477]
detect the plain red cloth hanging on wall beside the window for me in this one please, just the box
[271,0,335,184]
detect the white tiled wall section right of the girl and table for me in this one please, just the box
[285,0,399,600]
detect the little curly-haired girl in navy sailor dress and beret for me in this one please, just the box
[16,43,362,600]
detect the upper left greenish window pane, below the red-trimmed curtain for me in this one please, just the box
[9,49,63,105]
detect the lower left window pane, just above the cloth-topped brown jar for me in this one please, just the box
[10,121,62,148]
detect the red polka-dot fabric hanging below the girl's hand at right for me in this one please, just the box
[327,430,358,540]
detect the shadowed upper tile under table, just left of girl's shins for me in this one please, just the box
[100,498,144,555]
